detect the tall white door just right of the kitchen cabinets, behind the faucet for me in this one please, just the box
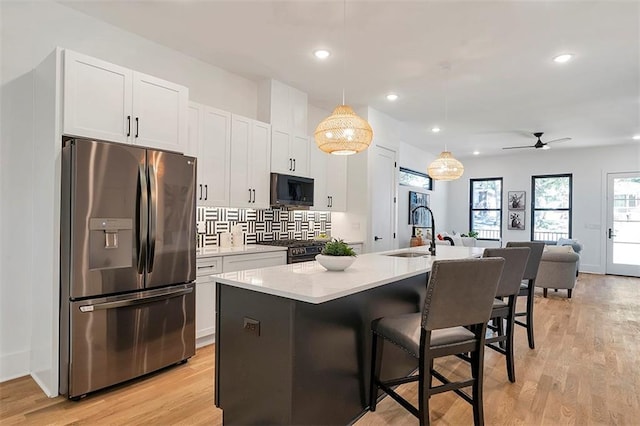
[370,146,396,252]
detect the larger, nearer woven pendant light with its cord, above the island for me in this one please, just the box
[314,0,373,155]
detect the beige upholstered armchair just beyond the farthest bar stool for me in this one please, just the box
[536,246,580,298]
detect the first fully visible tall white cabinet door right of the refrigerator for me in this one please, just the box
[197,107,231,207]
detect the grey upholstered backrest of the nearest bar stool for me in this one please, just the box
[422,258,504,331]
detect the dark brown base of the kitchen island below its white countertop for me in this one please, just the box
[215,274,427,425]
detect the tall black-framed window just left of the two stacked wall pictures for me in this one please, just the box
[469,178,502,240]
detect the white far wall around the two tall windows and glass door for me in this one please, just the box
[448,144,640,273]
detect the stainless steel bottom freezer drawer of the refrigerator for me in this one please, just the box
[61,283,195,398]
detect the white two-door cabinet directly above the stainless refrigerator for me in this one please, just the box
[63,50,189,152]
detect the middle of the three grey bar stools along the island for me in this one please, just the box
[482,247,531,383]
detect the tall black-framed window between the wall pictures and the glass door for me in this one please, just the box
[531,174,572,242]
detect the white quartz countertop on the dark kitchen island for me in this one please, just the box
[213,246,484,304]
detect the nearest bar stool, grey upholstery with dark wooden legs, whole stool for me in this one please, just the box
[369,258,505,425]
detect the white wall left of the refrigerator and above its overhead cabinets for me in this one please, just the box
[0,1,257,393]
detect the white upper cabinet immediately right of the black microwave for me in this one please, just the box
[309,146,347,211]
